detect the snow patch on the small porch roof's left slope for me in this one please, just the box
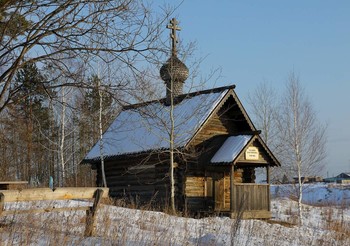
[210,135,253,163]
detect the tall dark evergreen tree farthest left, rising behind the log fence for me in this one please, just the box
[8,63,54,183]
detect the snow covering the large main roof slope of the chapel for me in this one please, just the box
[85,89,228,160]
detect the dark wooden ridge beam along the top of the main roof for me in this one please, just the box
[122,84,236,110]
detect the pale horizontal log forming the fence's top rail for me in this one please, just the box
[1,187,109,202]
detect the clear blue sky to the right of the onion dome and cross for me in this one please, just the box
[159,0,350,176]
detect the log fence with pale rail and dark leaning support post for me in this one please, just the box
[0,187,109,237]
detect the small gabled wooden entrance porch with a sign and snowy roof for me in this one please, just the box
[206,132,280,219]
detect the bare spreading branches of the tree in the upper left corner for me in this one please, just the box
[0,0,171,112]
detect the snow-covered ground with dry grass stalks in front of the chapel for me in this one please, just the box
[0,184,350,246]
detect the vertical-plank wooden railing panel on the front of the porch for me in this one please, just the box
[233,184,270,211]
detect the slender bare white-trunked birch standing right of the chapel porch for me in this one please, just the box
[278,73,326,224]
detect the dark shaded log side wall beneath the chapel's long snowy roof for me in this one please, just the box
[98,154,183,208]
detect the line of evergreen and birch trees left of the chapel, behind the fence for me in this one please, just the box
[0,63,115,186]
